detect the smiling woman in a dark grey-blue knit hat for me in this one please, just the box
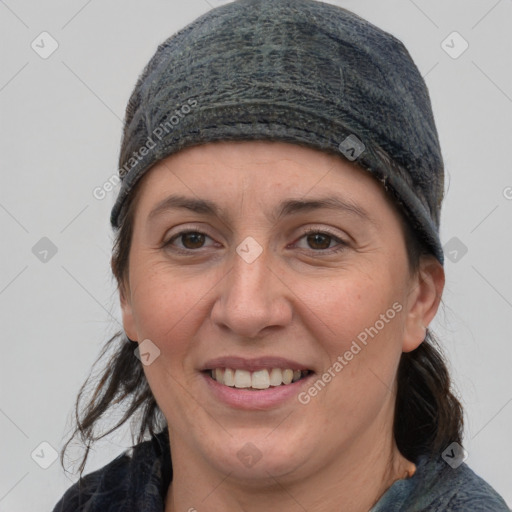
[54,0,508,512]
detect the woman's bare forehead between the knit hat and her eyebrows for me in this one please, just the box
[129,141,400,222]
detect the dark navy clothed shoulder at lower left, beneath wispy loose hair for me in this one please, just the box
[53,432,172,512]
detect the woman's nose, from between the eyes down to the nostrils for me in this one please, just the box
[211,240,292,339]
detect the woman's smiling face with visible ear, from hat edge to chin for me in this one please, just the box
[122,141,444,482]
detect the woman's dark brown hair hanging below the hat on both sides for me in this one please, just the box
[60,168,464,476]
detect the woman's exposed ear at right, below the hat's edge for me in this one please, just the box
[402,255,445,352]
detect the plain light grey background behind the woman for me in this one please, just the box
[0,0,512,512]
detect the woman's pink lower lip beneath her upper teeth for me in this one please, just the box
[203,372,314,410]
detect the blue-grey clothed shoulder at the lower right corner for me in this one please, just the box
[408,460,510,512]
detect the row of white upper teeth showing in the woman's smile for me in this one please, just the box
[205,368,312,391]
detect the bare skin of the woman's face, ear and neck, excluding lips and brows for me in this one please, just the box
[120,141,444,512]
